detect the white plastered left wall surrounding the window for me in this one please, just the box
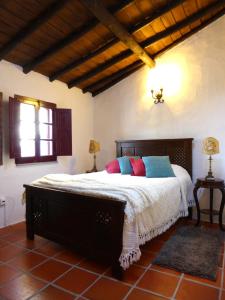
[0,61,93,227]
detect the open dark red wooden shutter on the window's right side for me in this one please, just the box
[53,108,72,156]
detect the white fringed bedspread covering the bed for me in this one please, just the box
[32,165,192,269]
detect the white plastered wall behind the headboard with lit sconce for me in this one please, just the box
[94,17,225,221]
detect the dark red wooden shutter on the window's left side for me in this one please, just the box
[9,97,20,158]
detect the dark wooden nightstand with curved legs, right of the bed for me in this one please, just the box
[193,178,225,231]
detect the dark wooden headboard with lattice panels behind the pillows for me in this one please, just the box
[116,138,193,177]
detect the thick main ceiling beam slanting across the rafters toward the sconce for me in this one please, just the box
[80,0,155,68]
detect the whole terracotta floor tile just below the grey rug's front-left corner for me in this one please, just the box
[138,270,179,297]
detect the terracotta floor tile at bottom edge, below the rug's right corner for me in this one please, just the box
[176,280,219,300]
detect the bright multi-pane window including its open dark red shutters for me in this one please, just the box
[9,96,72,164]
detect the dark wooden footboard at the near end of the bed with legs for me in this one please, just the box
[24,185,126,279]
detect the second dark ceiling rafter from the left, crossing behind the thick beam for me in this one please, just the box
[23,0,133,74]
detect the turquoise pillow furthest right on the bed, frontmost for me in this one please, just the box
[142,156,175,178]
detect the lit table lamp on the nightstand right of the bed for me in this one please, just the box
[203,137,219,180]
